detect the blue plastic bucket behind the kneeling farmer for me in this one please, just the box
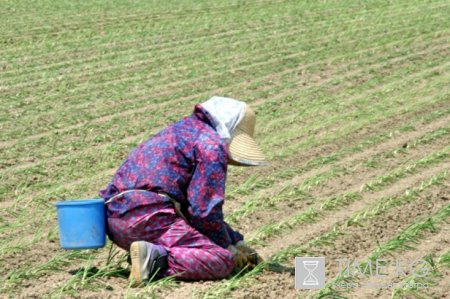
[55,199,106,249]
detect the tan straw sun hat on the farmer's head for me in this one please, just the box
[228,105,267,166]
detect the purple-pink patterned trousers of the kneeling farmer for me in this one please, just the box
[107,202,234,280]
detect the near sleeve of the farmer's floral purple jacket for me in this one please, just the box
[187,144,235,248]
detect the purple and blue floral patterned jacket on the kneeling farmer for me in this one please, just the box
[100,104,243,248]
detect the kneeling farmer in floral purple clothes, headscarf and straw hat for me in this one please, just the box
[100,97,266,285]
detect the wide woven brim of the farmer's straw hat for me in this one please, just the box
[228,127,267,166]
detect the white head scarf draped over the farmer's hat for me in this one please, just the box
[201,96,247,143]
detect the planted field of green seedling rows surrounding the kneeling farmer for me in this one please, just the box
[0,0,450,298]
